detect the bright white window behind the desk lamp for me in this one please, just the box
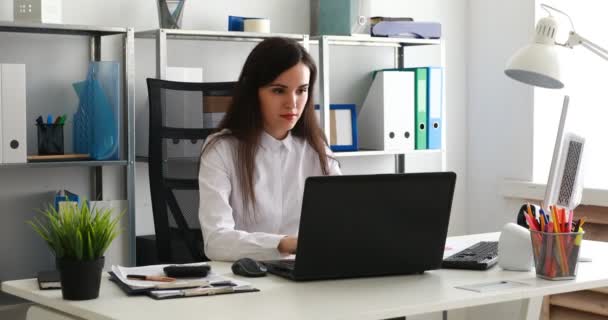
[533,0,608,189]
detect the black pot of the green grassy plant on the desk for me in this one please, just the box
[56,257,104,300]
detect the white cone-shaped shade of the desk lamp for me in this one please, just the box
[505,17,564,89]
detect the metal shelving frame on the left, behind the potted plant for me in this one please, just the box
[0,21,135,265]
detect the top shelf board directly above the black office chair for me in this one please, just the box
[135,29,305,42]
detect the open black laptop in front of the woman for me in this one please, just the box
[263,172,456,281]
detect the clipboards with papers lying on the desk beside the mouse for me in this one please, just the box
[109,262,260,300]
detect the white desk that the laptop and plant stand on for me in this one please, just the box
[2,233,608,320]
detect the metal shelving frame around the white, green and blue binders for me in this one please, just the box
[309,36,447,173]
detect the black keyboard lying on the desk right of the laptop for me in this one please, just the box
[441,241,498,270]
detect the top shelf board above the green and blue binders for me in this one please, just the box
[310,35,441,47]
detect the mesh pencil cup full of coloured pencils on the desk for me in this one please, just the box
[530,230,584,280]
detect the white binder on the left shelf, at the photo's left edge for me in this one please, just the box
[0,64,27,163]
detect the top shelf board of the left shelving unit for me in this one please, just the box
[0,21,128,36]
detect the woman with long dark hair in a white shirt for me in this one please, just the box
[199,38,340,261]
